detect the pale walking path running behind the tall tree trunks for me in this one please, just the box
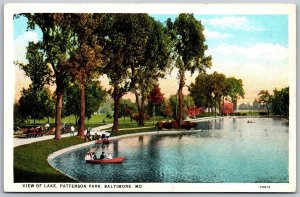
[14,123,113,147]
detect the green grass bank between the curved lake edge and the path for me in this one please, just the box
[14,127,156,183]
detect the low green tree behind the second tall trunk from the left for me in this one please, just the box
[63,80,107,124]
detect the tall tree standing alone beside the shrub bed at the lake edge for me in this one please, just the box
[167,14,211,125]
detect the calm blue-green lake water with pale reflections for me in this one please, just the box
[52,118,289,183]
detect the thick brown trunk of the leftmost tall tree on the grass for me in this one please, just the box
[54,82,63,140]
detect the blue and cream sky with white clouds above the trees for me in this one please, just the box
[14,14,289,103]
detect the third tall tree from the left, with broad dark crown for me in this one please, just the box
[103,14,158,131]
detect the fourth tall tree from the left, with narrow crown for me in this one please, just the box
[132,17,170,126]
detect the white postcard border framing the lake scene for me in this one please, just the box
[4,3,296,192]
